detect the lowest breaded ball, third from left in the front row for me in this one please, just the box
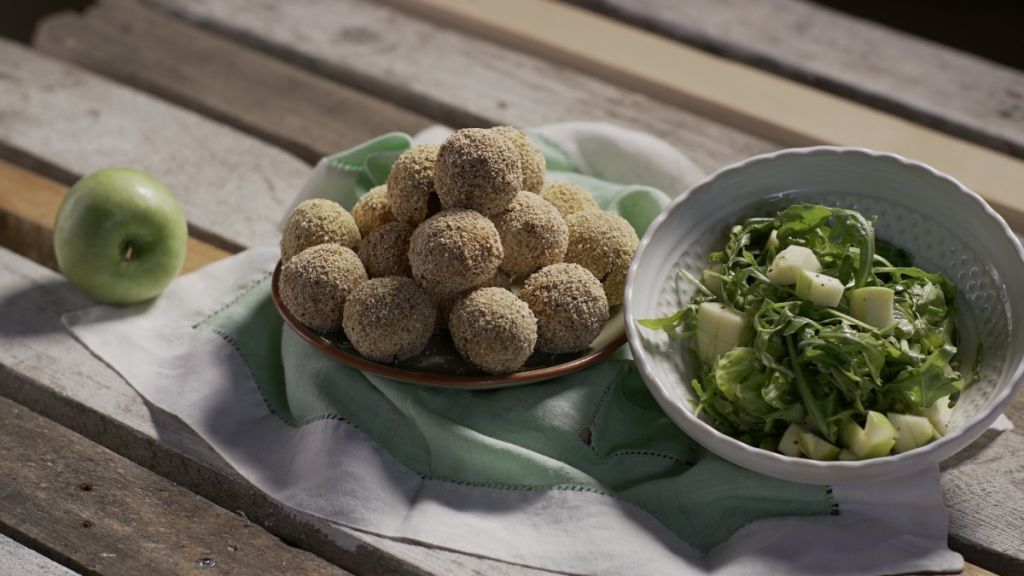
[449,288,537,374]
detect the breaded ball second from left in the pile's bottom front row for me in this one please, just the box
[343,276,435,363]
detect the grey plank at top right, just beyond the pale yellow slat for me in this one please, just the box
[568,0,1024,156]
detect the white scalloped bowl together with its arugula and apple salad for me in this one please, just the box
[625,147,1024,484]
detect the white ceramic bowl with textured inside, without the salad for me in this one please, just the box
[626,147,1024,484]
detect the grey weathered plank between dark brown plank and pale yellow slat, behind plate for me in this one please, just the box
[140,0,778,170]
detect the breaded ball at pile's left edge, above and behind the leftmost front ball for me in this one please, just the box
[281,198,361,262]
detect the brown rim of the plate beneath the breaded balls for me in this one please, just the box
[270,260,626,389]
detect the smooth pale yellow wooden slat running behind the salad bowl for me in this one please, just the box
[382,0,1024,229]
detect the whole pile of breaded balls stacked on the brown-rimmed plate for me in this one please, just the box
[279,126,639,374]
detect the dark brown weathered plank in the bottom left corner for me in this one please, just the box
[0,399,349,576]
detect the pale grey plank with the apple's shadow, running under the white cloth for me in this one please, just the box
[0,248,565,576]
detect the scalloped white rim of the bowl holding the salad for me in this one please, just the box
[624,146,1024,484]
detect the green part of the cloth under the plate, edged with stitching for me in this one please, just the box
[205,134,834,552]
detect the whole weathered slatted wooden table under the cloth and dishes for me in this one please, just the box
[0,0,1024,575]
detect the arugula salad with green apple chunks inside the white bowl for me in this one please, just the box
[639,204,966,460]
